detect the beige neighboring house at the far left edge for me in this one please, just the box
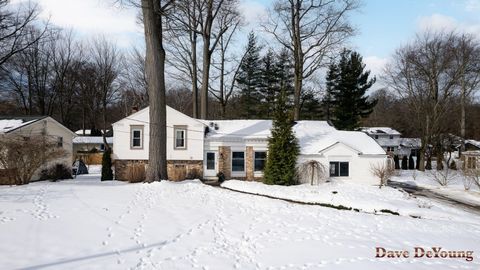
[0,116,76,181]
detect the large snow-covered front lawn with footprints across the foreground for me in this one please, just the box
[0,175,480,269]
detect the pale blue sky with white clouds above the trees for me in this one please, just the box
[33,0,480,78]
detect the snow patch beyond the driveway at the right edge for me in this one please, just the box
[391,170,480,205]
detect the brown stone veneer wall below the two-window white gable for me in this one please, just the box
[114,159,203,181]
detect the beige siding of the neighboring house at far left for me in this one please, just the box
[8,117,75,181]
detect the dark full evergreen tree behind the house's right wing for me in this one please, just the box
[327,50,377,130]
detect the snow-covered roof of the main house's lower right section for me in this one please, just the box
[201,120,385,155]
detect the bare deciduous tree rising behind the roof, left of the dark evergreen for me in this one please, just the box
[263,0,359,120]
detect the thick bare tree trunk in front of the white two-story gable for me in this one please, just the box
[142,0,168,182]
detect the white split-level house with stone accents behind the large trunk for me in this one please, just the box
[113,106,387,184]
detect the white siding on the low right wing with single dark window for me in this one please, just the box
[298,143,387,185]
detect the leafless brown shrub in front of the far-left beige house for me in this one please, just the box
[0,135,67,185]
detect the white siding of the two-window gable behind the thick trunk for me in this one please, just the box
[113,106,205,180]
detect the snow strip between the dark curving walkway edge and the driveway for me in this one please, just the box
[222,180,480,224]
